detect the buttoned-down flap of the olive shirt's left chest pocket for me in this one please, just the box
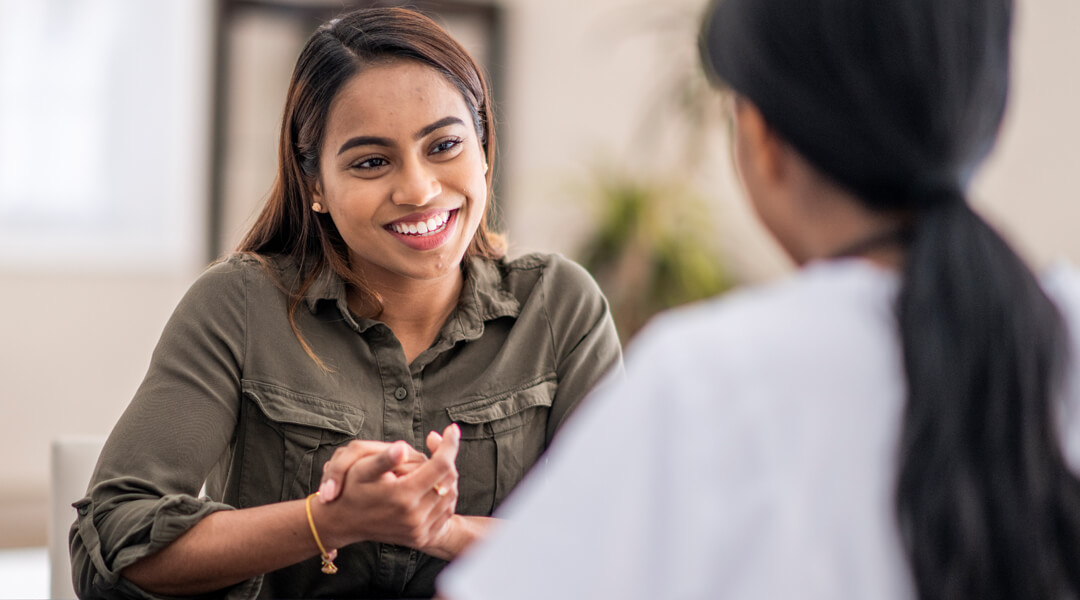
[241,379,364,436]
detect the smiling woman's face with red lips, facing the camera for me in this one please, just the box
[313,59,487,286]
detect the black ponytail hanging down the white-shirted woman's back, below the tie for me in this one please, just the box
[896,197,1080,599]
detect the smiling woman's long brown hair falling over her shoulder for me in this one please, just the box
[237,8,505,366]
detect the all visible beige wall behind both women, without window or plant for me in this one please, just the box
[0,0,1080,546]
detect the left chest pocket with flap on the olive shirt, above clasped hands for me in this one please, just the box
[237,380,364,507]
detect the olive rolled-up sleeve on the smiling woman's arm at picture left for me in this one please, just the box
[69,259,260,598]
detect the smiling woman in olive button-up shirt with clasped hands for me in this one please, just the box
[71,9,621,598]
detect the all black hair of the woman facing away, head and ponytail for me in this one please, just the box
[702,0,1080,599]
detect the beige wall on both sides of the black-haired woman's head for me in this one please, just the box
[494,0,1080,279]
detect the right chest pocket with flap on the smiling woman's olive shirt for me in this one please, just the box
[446,376,556,516]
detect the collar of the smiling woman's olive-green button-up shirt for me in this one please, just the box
[303,257,522,341]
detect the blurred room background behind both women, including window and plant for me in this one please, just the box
[0,0,1080,565]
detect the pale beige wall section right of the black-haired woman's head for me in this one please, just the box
[975,0,1080,264]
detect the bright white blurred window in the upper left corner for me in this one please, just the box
[0,0,213,269]
